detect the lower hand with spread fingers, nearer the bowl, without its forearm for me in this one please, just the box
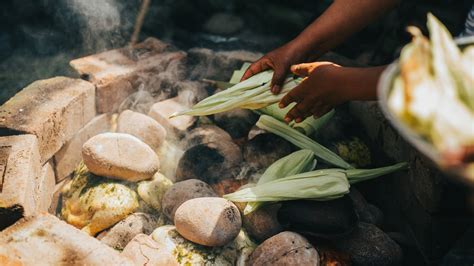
[279,62,348,123]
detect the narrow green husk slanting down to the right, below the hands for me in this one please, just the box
[257,115,353,169]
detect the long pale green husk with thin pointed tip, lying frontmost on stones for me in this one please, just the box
[224,163,407,202]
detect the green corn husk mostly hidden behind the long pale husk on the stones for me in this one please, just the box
[244,150,316,215]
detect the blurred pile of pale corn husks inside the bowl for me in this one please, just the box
[388,14,474,156]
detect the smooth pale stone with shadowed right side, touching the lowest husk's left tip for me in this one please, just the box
[174,197,242,247]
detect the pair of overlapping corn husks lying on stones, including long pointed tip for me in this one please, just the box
[224,150,407,214]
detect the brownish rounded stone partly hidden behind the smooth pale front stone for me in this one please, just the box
[161,179,217,221]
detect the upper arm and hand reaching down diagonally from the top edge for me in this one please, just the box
[242,0,399,94]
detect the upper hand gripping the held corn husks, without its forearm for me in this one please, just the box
[242,42,307,94]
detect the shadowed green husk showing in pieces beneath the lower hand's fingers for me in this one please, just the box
[255,103,335,136]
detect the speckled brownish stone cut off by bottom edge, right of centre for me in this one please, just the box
[248,231,320,266]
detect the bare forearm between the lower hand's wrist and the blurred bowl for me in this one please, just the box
[336,66,387,101]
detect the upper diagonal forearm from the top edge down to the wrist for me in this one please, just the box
[291,0,399,60]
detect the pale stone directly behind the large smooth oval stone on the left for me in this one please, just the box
[117,110,166,150]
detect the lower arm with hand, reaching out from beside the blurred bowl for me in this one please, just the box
[279,62,386,122]
